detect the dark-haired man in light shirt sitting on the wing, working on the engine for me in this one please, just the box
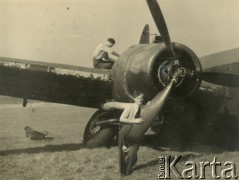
[93,38,119,69]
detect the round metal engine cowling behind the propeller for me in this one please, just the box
[113,43,201,102]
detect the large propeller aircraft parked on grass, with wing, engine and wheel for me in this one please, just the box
[0,0,239,148]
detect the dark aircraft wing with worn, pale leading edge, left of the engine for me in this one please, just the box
[0,57,112,108]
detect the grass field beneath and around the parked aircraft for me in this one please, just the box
[0,100,239,180]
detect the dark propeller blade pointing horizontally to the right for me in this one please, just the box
[196,71,239,87]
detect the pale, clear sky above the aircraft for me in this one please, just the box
[0,0,239,67]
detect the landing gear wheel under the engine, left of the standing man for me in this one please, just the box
[84,110,119,148]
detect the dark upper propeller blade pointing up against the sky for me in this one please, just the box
[147,0,176,57]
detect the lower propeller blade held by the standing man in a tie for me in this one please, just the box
[129,80,175,142]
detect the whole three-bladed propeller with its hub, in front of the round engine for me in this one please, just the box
[128,0,239,143]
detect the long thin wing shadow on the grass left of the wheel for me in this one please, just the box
[0,143,85,156]
